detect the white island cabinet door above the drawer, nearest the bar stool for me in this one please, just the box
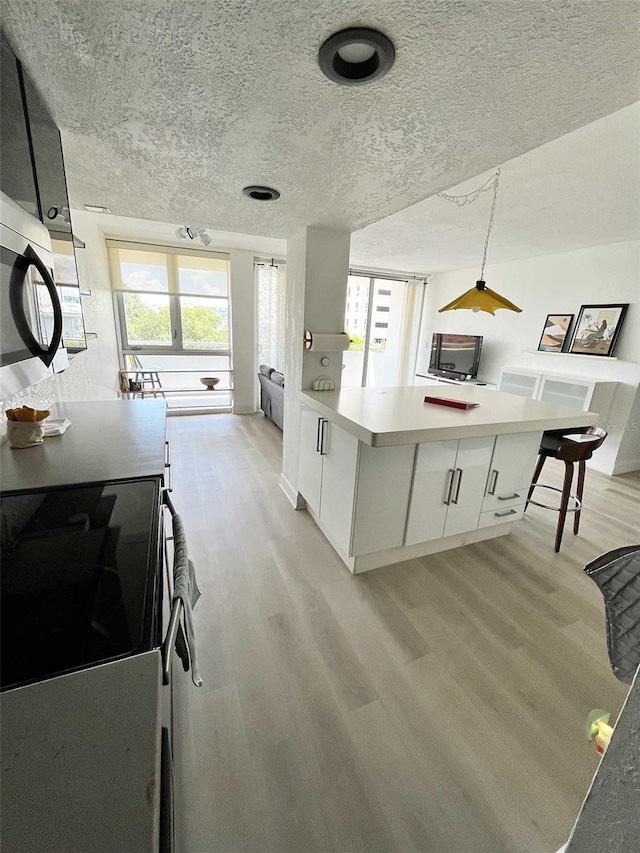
[482,431,542,512]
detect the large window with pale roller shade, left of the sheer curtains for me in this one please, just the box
[107,241,232,409]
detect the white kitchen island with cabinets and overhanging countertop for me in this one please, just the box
[298,386,598,574]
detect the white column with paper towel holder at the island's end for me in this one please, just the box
[280,226,351,505]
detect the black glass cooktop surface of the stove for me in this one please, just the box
[0,480,162,689]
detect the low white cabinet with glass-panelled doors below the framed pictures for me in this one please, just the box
[498,367,618,426]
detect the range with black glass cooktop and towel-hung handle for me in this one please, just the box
[0,478,191,853]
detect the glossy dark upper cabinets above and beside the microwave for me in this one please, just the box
[0,30,86,352]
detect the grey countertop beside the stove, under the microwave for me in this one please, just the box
[0,400,166,492]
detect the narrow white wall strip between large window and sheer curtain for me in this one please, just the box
[229,249,257,415]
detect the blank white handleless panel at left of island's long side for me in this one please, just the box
[352,442,418,556]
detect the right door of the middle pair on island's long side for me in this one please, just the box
[444,436,495,536]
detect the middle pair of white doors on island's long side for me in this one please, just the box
[405,436,495,545]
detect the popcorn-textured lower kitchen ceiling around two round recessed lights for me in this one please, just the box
[2,0,640,237]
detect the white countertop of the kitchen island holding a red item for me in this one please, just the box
[299,385,598,447]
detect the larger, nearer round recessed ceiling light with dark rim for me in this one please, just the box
[318,27,396,86]
